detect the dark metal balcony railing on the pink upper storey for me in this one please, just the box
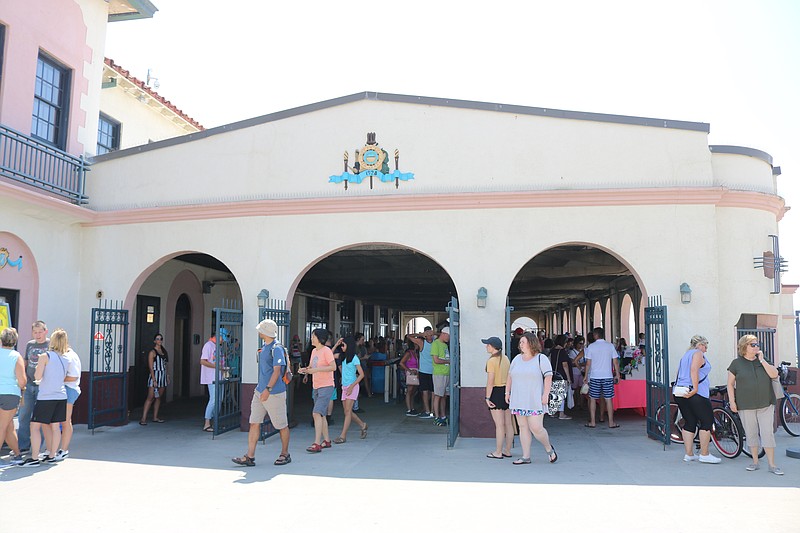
[0,125,89,205]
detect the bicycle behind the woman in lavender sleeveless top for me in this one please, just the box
[656,385,748,459]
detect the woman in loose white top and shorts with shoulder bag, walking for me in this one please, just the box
[506,333,558,465]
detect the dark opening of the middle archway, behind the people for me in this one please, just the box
[289,243,456,424]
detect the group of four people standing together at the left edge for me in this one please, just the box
[0,320,81,467]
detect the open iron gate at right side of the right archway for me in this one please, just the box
[644,296,672,445]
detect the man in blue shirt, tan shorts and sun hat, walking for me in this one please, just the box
[232,319,292,466]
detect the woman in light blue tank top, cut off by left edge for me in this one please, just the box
[0,328,28,464]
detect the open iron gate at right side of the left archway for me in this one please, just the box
[213,301,242,436]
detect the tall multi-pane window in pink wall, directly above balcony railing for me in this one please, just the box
[31,53,70,150]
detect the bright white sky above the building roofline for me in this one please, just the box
[106,0,800,290]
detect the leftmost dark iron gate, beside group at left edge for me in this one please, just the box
[89,301,128,433]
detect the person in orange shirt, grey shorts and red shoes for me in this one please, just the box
[300,328,336,453]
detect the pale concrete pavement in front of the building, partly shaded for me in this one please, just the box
[0,399,800,532]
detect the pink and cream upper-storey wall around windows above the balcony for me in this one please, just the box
[0,0,94,155]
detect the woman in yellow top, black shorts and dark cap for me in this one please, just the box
[481,337,514,459]
